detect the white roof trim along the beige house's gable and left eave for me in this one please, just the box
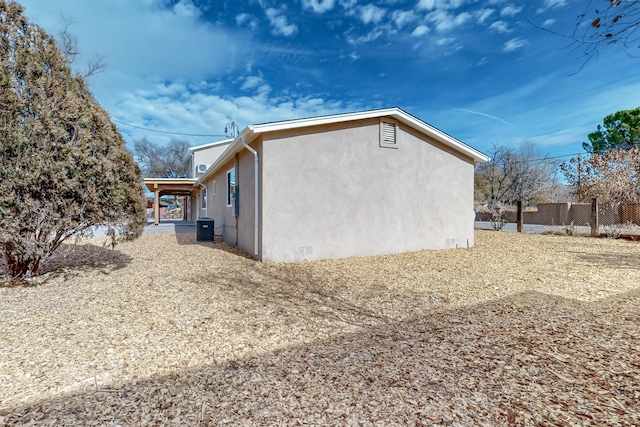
[196,108,489,185]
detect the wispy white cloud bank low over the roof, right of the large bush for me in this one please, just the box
[113,78,363,145]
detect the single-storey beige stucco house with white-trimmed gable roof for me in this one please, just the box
[191,108,488,262]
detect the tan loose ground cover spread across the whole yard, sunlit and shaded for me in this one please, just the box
[0,231,640,426]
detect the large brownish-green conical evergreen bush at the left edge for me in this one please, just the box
[0,0,145,276]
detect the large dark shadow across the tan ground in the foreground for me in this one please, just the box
[5,291,640,426]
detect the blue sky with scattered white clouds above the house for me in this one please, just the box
[13,0,640,160]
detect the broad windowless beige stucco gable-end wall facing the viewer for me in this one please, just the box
[261,119,474,262]
